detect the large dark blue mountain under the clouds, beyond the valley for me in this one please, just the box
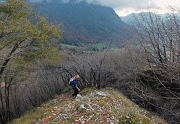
[31,0,130,45]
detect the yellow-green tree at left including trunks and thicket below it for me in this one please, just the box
[0,0,62,124]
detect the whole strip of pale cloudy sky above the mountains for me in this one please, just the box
[31,0,180,16]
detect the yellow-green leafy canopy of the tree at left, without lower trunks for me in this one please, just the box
[0,0,62,78]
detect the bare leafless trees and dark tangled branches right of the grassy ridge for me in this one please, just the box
[131,8,180,123]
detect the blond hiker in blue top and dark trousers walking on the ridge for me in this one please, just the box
[70,75,80,98]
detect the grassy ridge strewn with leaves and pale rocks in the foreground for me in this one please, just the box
[11,88,166,124]
